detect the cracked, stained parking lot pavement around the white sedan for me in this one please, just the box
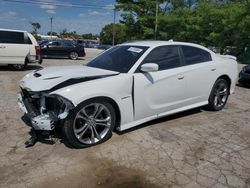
[0,49,250,188]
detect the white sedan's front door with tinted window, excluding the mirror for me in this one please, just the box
[134,45,186,120]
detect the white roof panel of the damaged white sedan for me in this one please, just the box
[121,40,211,51]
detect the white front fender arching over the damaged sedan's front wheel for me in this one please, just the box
[51,74,134,124]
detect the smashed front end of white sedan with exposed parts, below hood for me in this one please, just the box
[18,89,74,131]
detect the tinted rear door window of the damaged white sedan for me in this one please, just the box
[182,46,212,65]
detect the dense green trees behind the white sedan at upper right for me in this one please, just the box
[100,0,250,57]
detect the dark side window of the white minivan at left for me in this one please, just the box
[0,31,24,44]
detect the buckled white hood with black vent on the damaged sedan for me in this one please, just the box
[20,65,119,91]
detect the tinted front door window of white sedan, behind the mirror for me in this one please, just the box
[143,46,180,70]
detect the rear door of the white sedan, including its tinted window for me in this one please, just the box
[181,45,216,105]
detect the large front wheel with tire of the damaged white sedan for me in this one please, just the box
[63,100,115,148]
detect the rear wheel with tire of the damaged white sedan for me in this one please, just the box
[208,78,229,111]
